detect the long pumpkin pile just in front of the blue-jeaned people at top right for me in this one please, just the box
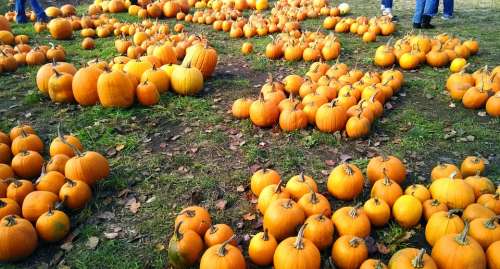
[374,33,479,70]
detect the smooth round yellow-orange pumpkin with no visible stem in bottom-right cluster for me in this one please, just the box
[392,194,422,228]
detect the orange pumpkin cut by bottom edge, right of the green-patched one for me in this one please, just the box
[199,237,246,269]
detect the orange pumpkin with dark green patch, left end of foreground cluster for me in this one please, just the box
[167,221,204,268]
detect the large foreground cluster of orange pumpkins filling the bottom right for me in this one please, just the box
[168,156,500,269]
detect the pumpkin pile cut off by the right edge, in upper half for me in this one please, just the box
[446,66,500,117]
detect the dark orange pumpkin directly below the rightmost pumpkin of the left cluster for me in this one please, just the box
[59,179,92,210]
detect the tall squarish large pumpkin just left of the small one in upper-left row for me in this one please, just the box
[97,70,135,107]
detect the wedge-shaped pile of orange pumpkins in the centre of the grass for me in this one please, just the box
[232,62,404,138]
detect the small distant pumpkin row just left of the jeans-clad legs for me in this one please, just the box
[323,16,396,43]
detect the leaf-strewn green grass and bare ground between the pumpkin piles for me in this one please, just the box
[0,0,500,268]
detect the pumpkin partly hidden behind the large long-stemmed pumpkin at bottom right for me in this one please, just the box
[425,209,465,246]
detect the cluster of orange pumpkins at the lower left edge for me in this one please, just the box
[0,124,110,262]
